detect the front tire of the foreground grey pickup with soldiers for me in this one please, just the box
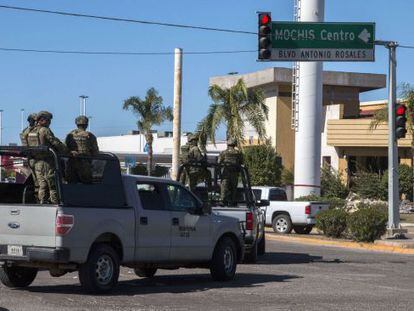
[210,237,237,281]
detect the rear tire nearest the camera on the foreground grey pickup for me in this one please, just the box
[79,244,119,294]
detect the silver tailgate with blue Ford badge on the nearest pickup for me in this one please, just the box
[0,204,58,247]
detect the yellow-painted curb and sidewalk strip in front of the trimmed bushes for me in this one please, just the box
[266,228,414,255]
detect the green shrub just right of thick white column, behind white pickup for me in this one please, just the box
[321,166,349,199]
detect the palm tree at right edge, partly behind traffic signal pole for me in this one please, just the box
[370,83,414,201]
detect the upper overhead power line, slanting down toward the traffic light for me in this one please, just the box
[0,5,257,35]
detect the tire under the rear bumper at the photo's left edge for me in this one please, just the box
[0,266,38,288]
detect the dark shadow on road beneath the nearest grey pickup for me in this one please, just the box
[26,273,300,296]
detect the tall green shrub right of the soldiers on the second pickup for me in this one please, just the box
[243,143,282,186]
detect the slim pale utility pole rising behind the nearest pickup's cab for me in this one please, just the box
[171,48,183,180]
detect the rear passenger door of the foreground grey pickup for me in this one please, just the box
[135,182,171,262]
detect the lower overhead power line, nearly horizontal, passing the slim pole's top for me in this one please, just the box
[0,47,257,56]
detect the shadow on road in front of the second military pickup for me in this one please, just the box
[257,253,343,265]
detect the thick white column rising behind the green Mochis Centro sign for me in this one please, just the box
[294,0,325,198]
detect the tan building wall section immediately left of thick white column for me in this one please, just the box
[275,97,295,170]
